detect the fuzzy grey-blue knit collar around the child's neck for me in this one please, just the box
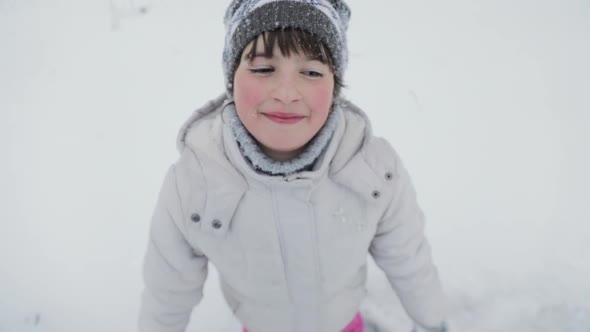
[226,103,338,176]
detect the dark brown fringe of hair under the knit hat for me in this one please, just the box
[234,28,344,96]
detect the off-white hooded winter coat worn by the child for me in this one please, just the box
[139,97,446,332]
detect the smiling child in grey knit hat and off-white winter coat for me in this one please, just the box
[139,0,446,332]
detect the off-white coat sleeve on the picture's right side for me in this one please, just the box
[370,152,447,328]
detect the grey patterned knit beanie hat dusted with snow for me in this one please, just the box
[223,0,350,96]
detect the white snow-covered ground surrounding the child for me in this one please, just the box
[0,0,590,332]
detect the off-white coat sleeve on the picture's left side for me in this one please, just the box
[139,166,207,332]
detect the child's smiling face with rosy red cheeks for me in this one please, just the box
[233,37,334,161]
